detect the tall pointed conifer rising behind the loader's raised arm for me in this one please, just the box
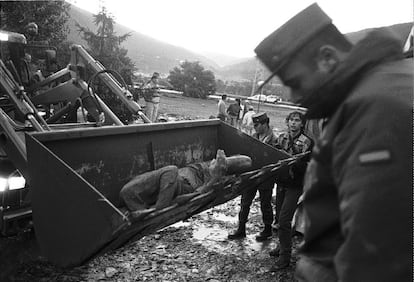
[76,7,135,123]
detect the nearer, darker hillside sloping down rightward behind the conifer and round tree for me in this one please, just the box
[68,5,220,74]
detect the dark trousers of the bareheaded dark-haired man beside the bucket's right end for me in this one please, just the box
[276,185,302,256]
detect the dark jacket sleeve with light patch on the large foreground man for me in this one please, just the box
[330,91,413,281]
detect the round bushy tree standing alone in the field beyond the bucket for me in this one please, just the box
[168,61,216,99]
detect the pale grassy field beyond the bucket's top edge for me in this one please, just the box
[153,94,293,133]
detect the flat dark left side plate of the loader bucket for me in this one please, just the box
[27,135,127,266]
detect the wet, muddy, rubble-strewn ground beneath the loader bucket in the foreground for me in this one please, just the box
[0,198,300,282]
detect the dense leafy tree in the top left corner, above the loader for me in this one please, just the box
[0,1,70,46]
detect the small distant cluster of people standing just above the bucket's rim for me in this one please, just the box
[217,94,256,135]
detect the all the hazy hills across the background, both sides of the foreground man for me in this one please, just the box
[68,5,412,81]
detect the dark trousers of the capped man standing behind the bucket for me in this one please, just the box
[239,181,274,225]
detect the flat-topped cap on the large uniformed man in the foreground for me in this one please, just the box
[254,3,332,85]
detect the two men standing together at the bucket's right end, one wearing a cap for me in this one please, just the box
[228,111,313,271]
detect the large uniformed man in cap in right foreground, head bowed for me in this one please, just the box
[255,3,414,281]
